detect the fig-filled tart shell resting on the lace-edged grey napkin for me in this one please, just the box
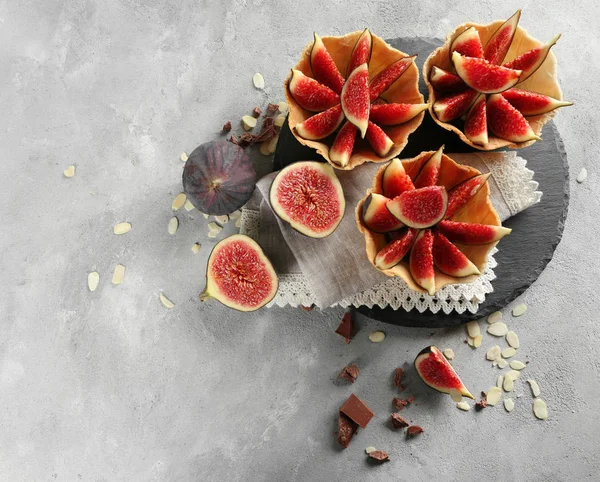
[356,150,511,295]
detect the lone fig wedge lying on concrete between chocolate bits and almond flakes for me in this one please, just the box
[414,345,475,401]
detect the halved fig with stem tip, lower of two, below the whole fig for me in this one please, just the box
[200,234,278,311]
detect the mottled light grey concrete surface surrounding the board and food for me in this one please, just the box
[0,0,600,481]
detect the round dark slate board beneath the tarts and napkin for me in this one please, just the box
[274,37,569,328]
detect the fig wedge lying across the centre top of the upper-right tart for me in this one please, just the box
[452,52,521,94]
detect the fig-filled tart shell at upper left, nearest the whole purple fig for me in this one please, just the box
[286,29,429,169]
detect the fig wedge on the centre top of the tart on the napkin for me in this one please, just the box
[386,186,448,229]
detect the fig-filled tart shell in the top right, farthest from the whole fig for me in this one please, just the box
[423,10,572,150]
